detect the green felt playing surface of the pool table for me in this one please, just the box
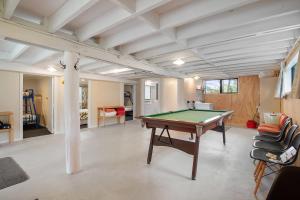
[146,110,226,123]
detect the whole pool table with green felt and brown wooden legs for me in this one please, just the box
[141,109,233,180]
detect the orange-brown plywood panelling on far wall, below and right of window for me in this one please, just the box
[204,76,260,126]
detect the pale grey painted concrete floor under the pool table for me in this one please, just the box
[0,121,272,200]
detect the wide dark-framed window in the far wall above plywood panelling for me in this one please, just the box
[205,78,238,94]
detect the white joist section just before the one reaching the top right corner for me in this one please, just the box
[160,0,257,29]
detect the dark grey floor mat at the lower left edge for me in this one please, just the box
[0,157,29,190]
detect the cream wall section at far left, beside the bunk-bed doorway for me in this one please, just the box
[0,71,22,143]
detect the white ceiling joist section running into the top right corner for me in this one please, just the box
[177,0,300,39]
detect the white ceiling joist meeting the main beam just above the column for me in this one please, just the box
[76,0,170,41]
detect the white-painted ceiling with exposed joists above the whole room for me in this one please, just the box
[0,0,300,79]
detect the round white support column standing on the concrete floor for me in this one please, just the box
[64,51,80,174]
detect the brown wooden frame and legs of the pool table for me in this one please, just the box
[141,110,233,180]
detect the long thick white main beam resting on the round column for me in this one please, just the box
[0,18,182,77]
